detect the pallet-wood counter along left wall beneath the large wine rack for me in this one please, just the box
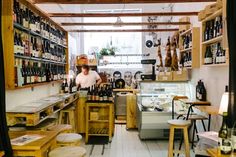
[6,93,78,126]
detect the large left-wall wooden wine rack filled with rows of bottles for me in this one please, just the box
[2,0,68,89]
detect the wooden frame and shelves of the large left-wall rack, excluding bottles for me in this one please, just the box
[2,0,69,89]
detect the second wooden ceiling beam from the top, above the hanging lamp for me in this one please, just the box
[48,12,198,17]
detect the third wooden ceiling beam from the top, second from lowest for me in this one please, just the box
[61,22,190,26]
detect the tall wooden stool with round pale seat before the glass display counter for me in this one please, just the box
[168,119,191,157]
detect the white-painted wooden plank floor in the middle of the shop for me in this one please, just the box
[82,124,194,157]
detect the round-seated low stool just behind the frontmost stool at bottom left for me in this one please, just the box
[56,133,82,146]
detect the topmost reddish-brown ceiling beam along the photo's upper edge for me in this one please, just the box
[33,0,216,4]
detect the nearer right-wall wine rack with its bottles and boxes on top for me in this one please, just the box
[201,0,229,66]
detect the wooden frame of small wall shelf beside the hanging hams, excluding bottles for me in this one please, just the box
[179,27,200,69]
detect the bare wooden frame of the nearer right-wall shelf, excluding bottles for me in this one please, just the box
[201,0,229,67]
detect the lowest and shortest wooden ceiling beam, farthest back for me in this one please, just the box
[67,28,179,33]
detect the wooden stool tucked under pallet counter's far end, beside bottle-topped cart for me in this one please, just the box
[58,107,76,132]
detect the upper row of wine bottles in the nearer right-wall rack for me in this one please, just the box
[204,16,223,41]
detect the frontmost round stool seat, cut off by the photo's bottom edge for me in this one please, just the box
[49,146,86,157]
